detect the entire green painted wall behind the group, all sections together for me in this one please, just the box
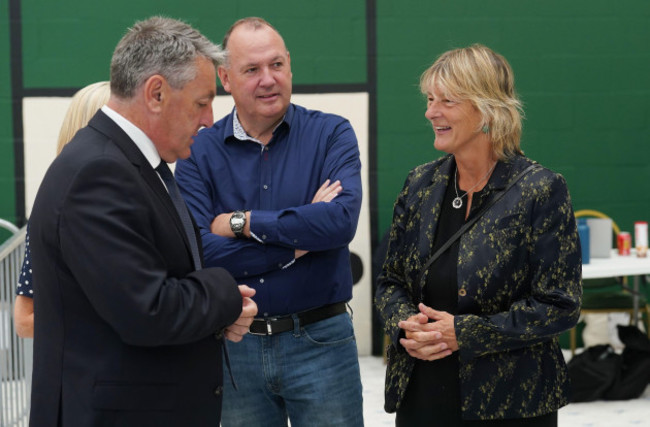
[0,0,650,254]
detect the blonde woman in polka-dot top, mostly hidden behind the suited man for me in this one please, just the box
[14,81,110,338]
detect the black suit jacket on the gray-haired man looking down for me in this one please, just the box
[30,111,242,426]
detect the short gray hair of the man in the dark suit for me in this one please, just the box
[111,16,224,99]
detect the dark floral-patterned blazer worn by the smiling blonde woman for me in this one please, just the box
[375,155,582,420]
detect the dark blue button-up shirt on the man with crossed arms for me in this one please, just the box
[176,104,361,316]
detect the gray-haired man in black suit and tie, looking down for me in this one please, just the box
[30,17,257,426]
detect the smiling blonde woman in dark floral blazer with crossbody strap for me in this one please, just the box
[376,45,582,427]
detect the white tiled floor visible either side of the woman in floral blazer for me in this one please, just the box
[359,356,650,427]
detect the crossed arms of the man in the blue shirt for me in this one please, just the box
[177,122,362,277]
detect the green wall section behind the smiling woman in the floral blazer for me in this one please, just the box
[377,0,650,237]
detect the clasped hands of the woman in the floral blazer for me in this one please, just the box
[398,303,458,360]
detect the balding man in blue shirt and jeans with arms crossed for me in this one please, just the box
[176,18,363,427]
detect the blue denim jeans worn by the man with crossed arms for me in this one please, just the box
[221,313,363,427]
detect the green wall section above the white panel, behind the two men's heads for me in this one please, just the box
[21,0,366,88]
